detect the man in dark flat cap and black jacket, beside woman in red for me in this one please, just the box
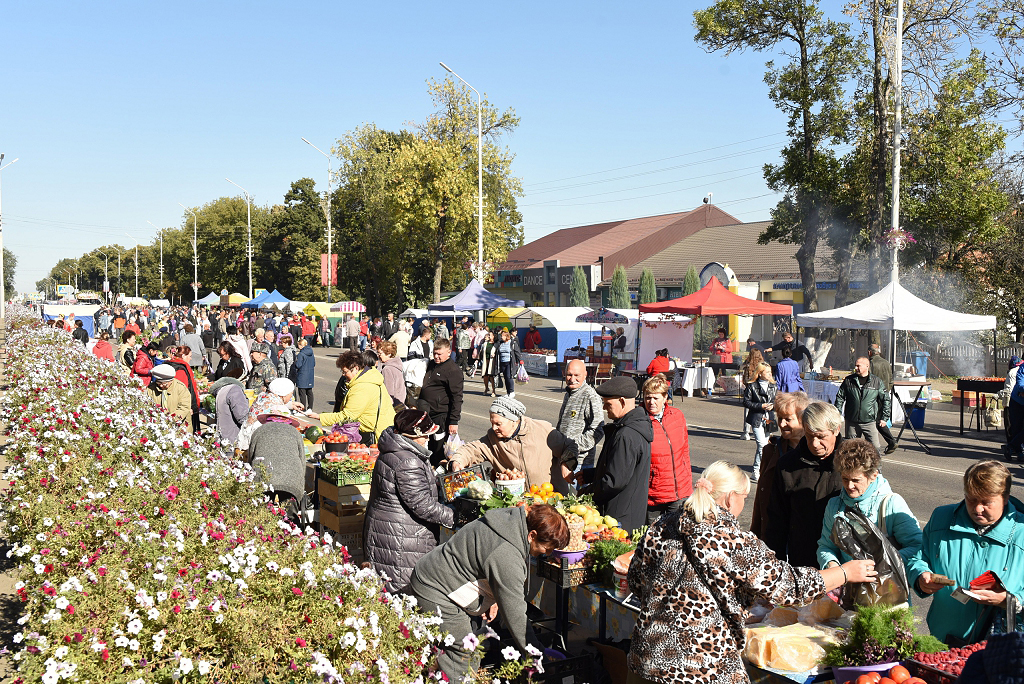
[589,376,654,533]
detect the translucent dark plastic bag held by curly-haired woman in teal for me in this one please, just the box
[831,507,910,610]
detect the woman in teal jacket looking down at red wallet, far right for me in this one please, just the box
[906,461,1024,645]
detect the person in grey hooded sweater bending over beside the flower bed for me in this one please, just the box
[409,504,569,682]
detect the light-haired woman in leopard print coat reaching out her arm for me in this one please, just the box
[629,461,876,684]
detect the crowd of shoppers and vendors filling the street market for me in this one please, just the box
[49,309,1024,682]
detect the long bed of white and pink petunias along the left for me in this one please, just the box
[0,308,442,684]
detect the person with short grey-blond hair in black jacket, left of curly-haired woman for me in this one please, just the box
[762,401,843,567]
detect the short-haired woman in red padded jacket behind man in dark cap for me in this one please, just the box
[642,374,693,525]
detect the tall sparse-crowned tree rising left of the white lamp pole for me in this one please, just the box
[693,0,858,311]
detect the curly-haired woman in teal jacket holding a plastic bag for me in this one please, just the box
[818,439,921,568]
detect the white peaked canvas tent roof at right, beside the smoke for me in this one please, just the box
[797,282,996,332]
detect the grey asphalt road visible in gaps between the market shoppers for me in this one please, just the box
[305,347,1024,629]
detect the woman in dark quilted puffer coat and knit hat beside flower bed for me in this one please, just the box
[362,409,455,591]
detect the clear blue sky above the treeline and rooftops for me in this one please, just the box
[0,2,785,291]
